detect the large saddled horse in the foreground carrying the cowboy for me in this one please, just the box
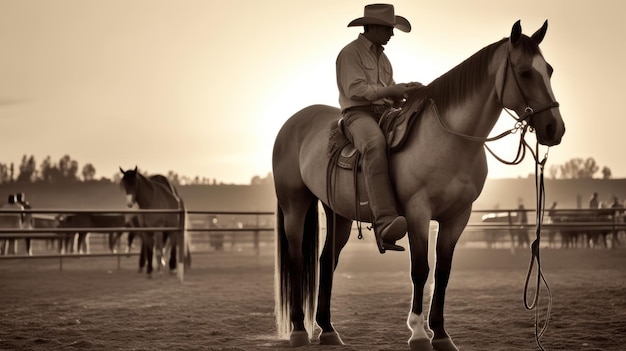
[273,21,565,350]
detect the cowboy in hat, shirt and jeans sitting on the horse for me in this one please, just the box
[336,4,423,251]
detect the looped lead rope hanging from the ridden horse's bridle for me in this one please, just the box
[524,143,552,351]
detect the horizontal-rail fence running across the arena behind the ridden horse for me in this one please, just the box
[0,209,626,281]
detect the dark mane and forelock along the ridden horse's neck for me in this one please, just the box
[407,35,539,112]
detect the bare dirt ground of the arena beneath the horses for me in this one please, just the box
[0,242,626,351]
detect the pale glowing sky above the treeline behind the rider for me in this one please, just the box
[0,0,626,184]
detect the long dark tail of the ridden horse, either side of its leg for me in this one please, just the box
[274,201,319,338]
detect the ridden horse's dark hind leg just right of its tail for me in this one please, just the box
[316,206,352,345]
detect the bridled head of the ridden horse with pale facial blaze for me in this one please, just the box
[497,20,565,146]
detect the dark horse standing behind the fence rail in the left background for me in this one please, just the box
[120,167,191,276]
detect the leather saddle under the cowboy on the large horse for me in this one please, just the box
[328,100,425,170]
